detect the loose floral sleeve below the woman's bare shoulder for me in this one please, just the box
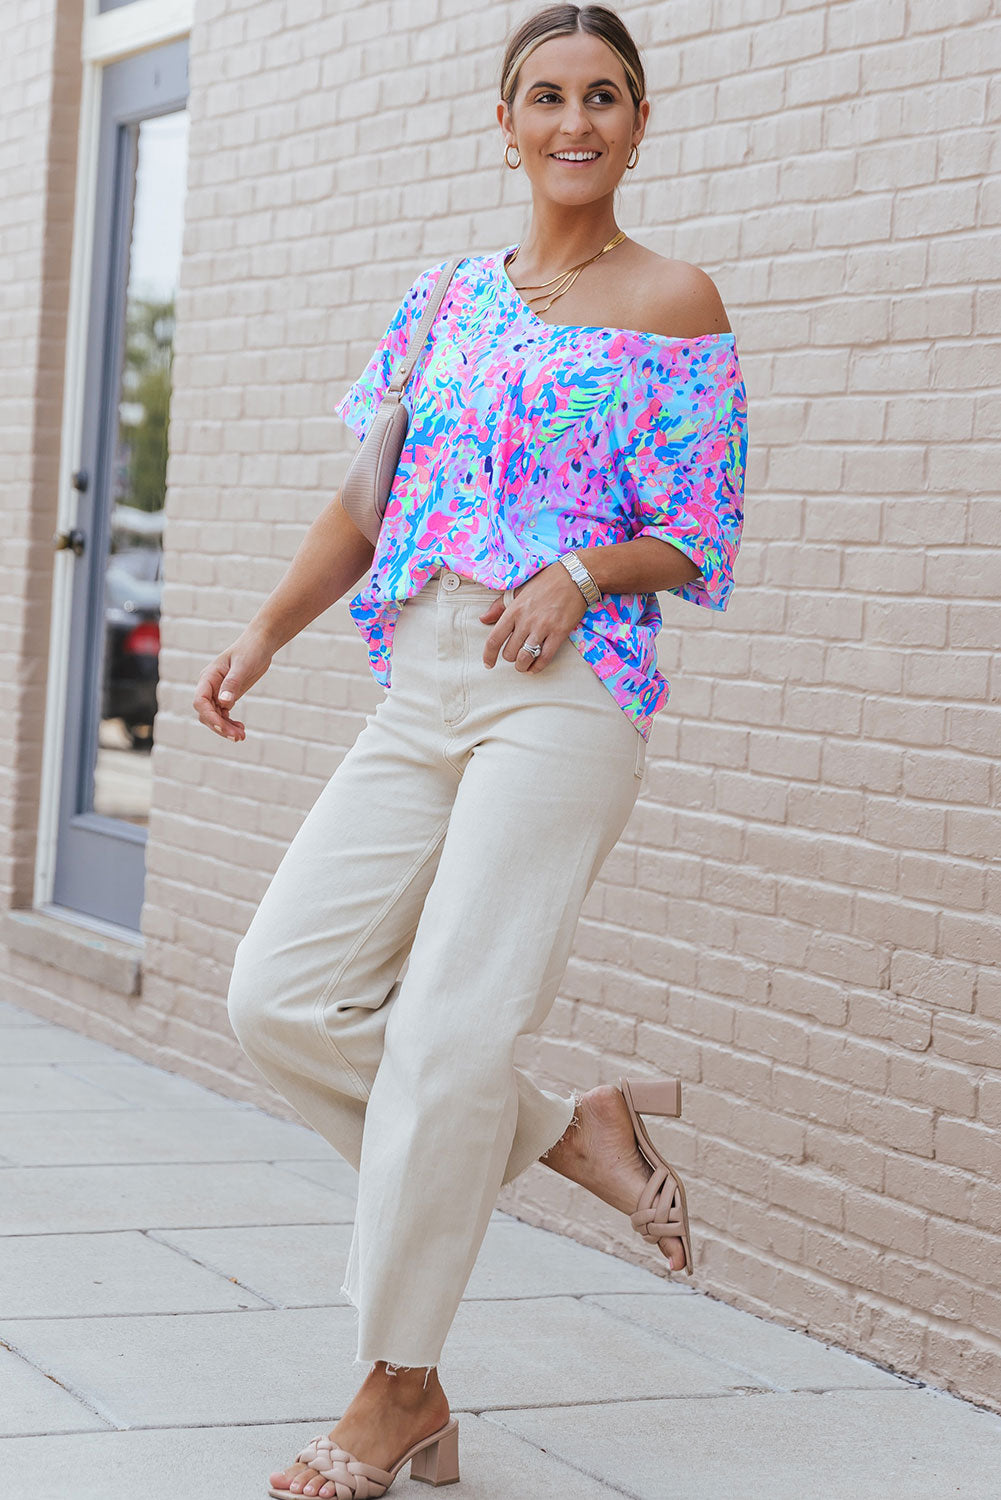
[615,341,747,609]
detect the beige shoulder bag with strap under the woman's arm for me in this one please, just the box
[341,255,465,545]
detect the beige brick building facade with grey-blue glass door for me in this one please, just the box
[0,0,1001,1407]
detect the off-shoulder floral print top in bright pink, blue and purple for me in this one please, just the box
[335,245,747,738]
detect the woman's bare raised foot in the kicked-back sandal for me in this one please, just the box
[539,1083,684,1271]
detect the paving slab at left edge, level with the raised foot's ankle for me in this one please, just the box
[0,1109,336,1185]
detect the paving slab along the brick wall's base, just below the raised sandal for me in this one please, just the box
[587,1292,908,1391]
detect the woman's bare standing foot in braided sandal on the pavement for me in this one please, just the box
[269,1359,450,1497]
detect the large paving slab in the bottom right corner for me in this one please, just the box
[489,1388,1001,1500]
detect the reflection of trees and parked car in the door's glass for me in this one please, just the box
[93,110,188,824]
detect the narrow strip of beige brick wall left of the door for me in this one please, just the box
[0,0,83,909]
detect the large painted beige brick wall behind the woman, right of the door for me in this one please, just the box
[1,0,1001,1406]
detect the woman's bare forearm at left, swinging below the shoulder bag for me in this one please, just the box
[246,492,375,651]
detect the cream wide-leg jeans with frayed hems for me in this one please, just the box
[228,569,645,1380]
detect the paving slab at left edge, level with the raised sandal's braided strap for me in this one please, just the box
[0,1161,354,1235]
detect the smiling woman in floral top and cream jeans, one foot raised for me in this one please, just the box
[195,5,746,1497]
